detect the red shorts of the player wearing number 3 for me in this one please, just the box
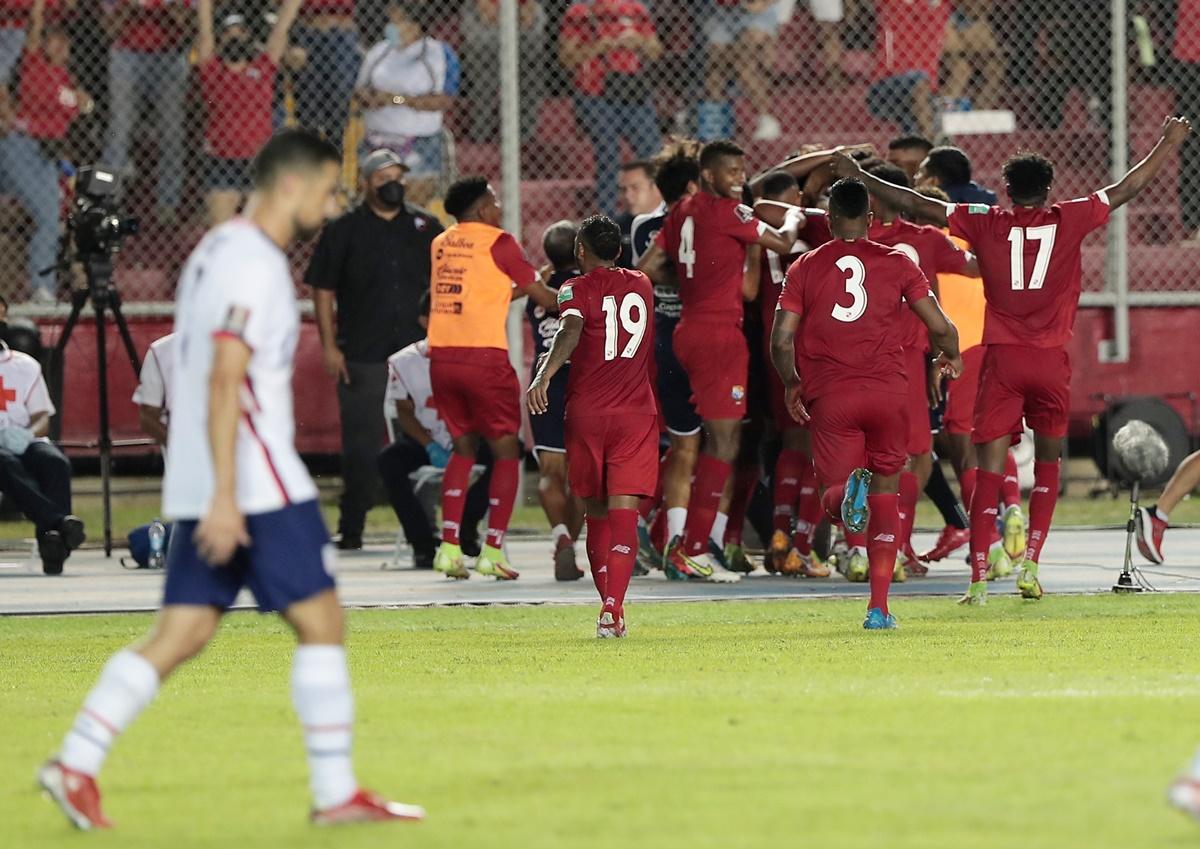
[809,387,902,487]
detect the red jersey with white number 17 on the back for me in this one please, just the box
[948,192,1109,348]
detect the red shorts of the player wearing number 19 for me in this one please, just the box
[566,414,659,498]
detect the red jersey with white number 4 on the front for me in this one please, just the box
[655,192,767,325]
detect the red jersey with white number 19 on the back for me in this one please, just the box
[558,269,656,419]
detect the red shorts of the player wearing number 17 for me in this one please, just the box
[972,345,1070,445]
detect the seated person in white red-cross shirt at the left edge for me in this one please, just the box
[0,342,86,574]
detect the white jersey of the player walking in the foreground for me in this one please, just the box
[163,218,317,519]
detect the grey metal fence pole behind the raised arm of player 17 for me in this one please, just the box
[1100,0,1129,362]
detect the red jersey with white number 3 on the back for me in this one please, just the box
[779,239,934,401]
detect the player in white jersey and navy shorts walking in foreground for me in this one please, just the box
[37,130,424,829]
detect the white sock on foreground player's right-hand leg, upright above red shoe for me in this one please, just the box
[292,645,359,809]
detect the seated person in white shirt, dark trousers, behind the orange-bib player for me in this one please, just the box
[378,291,491,568]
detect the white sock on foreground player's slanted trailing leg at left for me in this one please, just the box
[59,649,158,776]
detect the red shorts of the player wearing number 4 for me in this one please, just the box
[672,319,750,422]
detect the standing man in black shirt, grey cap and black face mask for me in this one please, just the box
[305,150,442,550]
